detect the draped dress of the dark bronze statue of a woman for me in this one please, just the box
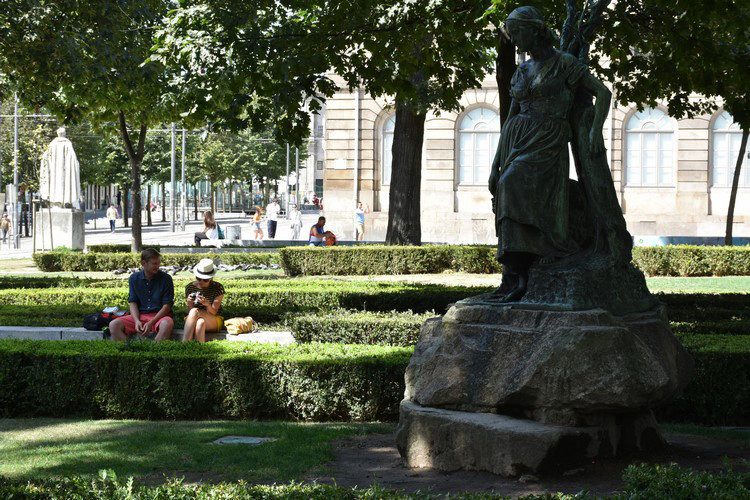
[493,50,587,262]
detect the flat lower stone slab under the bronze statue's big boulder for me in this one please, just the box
[396,400,664,476]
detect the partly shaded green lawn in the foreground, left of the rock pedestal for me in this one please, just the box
[0,418,394,482]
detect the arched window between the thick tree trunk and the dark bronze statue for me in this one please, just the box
[458,108,500,185]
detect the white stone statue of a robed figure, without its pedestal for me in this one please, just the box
[39,127,81,209]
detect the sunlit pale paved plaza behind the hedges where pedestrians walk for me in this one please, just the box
[0,212,328,259]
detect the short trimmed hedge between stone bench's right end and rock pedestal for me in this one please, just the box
[290,311,435,346]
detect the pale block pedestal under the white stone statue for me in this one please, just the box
[34,207,86,250]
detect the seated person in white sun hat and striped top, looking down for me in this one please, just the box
[182,259,224,342]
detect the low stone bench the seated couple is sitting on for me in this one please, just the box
[0,326,294,344]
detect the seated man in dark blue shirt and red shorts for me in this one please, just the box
[109,248,174,342]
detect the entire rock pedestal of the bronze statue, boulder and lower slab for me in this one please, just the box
[397,299,693,475]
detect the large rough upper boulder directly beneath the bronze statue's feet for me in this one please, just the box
[405,302,693,425]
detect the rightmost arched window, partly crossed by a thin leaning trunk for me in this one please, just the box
[711,111,750,187]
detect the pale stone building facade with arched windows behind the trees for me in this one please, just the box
[316,77,750,243]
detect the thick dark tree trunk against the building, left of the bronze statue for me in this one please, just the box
[385,100,425,245]
